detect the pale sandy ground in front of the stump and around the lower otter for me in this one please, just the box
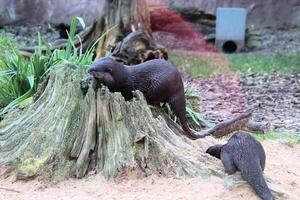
[0,141,300,200]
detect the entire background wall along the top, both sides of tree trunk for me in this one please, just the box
[0,0,300,28]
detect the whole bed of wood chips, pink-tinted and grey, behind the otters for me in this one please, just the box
[186,73,300,134]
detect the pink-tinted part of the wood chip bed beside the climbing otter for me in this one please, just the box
[186,75,246,124]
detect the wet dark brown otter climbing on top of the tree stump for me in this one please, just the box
[88,57,206,140]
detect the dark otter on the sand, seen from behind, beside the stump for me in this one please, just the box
[206,131,274,200]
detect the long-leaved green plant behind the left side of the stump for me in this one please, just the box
[0,17,103,115]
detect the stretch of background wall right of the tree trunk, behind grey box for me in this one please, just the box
[157,0,300,28]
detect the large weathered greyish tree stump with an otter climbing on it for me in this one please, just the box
[0,65,224,180]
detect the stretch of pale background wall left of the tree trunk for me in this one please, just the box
[0,0,104,25]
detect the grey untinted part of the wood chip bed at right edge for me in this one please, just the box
[241,73,300,134]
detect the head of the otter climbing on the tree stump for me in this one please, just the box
[88,57,124,91]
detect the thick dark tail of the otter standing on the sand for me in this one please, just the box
[241,165,275,200]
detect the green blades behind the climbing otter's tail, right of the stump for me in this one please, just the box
[161,84,212,131]
